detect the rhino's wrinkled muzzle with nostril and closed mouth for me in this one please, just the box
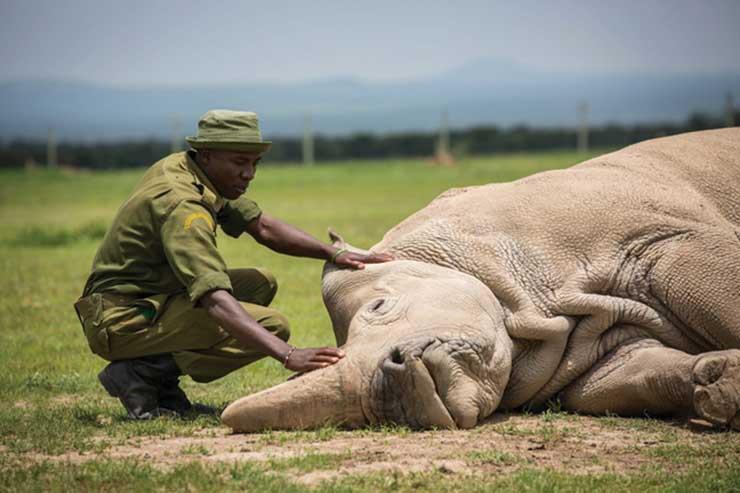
[367,338,492,429]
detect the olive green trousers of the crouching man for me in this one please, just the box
[75,268,290,382]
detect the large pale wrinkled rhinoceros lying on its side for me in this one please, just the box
[222,128,740,431]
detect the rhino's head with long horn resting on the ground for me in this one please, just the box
[222,236,512,431]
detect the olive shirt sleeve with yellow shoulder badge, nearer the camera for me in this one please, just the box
[162,201,232,303]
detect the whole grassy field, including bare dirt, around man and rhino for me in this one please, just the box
[0,153,740,492]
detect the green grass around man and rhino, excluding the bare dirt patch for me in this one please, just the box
[5,148,740,492]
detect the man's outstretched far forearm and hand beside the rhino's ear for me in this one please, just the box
[247,209,392,269]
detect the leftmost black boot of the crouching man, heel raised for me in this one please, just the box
[98,360,160,419]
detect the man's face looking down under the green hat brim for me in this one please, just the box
[198,149,262,200]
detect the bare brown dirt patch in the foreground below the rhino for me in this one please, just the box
[21,415,740,484]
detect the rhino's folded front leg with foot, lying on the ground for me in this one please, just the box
[560,339,740,429]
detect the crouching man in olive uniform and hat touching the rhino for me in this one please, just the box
[75,110,390,419]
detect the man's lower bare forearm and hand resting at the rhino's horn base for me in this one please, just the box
[200,289,344,372]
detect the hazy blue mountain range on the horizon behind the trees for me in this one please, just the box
[0,59,740,140]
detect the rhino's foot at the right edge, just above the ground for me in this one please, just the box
[692,350,740,430]
